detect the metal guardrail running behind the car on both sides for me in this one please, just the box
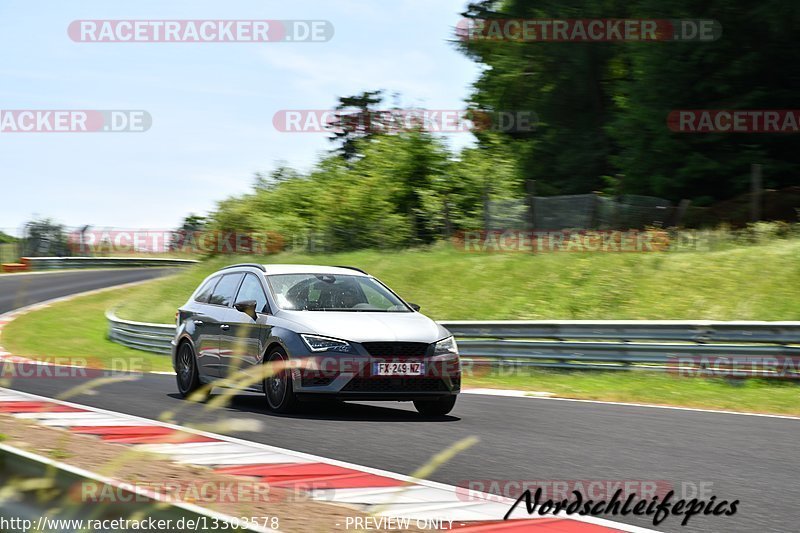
[106,312,800,378]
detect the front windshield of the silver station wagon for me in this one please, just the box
[267,274,410,313]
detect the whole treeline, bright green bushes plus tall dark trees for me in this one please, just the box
[209,0,800,250]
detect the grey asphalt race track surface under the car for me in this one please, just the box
[0,271,800,532]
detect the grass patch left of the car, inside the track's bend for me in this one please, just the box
[0,287,172,372]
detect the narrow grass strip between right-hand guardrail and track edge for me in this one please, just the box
[464,369,800,416]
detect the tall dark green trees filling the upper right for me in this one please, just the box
[462,0,800,200]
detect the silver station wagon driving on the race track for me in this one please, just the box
[172,264,461,416]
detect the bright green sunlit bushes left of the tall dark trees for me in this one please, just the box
[210,131,520,251]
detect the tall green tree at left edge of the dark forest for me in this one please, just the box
[459,0,628,194]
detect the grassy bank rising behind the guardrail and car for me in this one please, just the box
[119,239,800,322]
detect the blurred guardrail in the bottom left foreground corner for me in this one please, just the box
[0,444,273,533]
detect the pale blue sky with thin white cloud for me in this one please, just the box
[0,0,480,233]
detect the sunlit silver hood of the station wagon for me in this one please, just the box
[280,311,450,343]
